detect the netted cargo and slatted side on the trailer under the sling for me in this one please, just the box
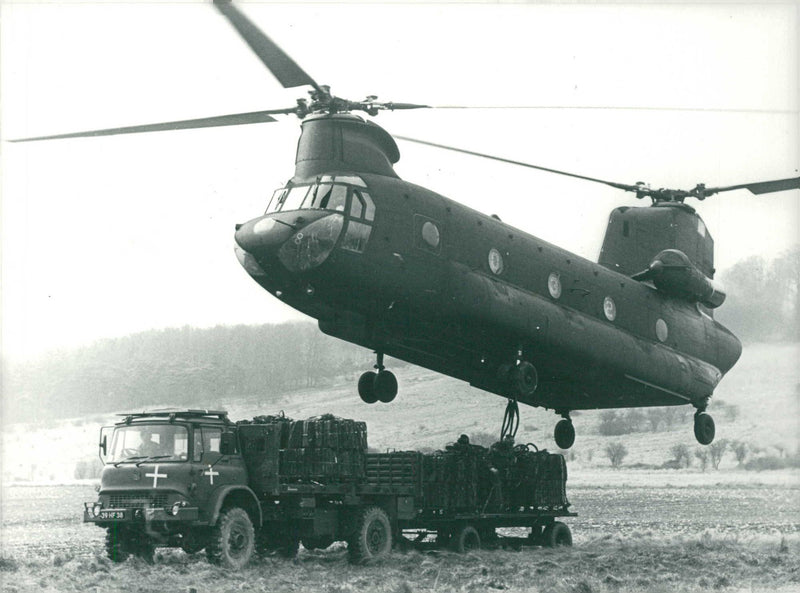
[367,435,570,513]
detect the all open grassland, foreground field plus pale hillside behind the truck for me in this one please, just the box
[0,344,800,593]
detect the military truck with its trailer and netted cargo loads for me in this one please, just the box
[83,409,577,569]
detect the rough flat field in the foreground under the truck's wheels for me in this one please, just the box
[0,471,800,593]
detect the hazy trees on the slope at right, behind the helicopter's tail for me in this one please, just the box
[715,246,800,341]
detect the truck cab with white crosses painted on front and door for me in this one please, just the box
[83,410,261,561]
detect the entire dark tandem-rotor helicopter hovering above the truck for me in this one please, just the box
[16,0,800,449]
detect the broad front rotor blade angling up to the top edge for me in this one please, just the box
[214,0,322,92]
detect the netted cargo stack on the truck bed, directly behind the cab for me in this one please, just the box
[238,414,367,492]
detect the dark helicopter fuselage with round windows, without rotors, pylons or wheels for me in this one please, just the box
[236,160,741,412]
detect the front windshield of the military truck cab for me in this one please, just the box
[106,424,189,463]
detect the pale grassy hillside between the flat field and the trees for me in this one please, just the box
[2,344,800,484]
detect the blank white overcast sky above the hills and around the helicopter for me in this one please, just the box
[0,1,800,358]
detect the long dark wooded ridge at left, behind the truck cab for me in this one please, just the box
[3,323,374,421]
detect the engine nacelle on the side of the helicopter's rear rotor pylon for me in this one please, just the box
[633,249,726,309]
